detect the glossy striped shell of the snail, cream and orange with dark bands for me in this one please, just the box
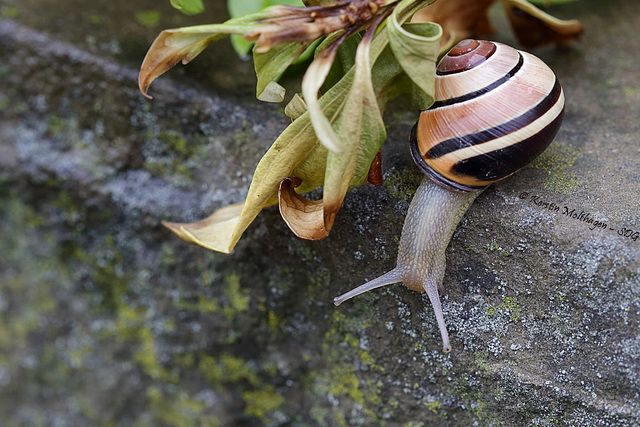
[411,40,564,192]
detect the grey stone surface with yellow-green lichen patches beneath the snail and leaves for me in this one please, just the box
[0,0,640,426]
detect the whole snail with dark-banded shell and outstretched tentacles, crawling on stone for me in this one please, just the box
[334,39,564,352]
